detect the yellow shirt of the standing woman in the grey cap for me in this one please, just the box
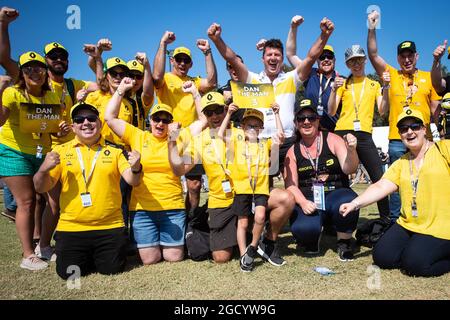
[335,77,381,133]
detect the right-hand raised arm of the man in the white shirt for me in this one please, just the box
[296,18,334,81]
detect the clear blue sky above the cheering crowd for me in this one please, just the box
[2,0,450,84]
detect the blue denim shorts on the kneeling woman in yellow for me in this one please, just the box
[131,210,186,249]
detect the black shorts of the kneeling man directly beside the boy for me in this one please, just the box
[208,206,237,251]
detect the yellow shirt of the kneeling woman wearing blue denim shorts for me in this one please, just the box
[119,124,190,211]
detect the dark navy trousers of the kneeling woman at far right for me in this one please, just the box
[373,223,450,277]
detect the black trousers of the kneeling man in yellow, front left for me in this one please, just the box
[55,228,127,279]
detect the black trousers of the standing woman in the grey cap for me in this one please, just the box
[335,130,390,217]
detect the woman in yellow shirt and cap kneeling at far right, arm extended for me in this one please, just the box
[340,109,450,277]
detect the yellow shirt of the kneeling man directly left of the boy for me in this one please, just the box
[188,128,236,209]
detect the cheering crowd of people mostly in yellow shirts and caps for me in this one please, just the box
[0,7,450,279]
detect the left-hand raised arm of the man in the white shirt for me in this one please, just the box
[208,23,248,82]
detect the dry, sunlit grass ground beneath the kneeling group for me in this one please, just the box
[0,185,450,300]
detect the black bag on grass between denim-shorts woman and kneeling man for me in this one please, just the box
[186,203,211,261]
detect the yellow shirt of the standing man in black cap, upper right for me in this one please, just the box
[387,65,440,139]
